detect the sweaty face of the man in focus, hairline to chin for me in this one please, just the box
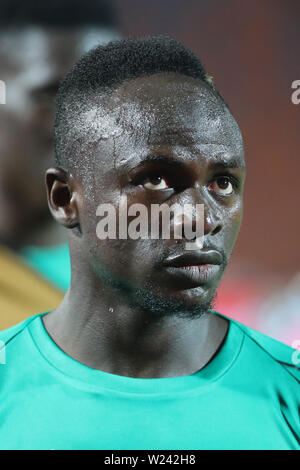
[72,74,245,315]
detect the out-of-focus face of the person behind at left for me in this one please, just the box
[0,28,116,243]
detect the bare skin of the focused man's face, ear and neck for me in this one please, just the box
[43,74,245,378]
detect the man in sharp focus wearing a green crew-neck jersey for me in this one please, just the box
[0,37,300,450]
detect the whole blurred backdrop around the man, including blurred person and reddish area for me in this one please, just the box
[0,0,300,345]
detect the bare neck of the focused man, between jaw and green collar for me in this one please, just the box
[43,264,228,378]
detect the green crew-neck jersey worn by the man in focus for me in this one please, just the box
[0,312,300,450]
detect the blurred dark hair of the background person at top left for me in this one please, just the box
[0,0,118,30]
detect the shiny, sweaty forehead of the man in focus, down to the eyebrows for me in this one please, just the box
[89,73,243,170]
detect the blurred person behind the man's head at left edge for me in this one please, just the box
[0,0,118,328]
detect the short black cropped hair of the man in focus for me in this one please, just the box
[55,36,226,168]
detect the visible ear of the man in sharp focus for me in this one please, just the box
[46,167,79,228]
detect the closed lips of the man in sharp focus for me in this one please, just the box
[163,250,223,288]
